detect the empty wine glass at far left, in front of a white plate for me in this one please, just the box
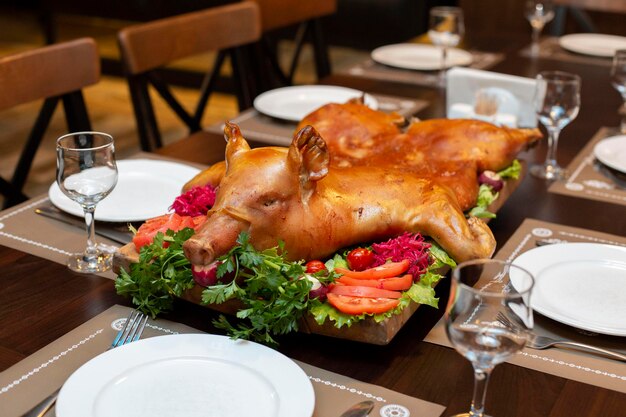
[57,132,117,273]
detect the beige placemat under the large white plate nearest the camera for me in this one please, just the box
[0,306,445,417]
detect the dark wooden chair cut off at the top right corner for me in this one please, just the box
[551,0,626,36]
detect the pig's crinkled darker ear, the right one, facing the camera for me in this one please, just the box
[288,126,330,191]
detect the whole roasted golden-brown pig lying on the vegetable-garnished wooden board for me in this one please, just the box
[184,103,540,265]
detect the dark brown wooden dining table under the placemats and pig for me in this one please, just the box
[0,36,626,417]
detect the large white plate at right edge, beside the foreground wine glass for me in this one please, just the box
[513,243,626,336]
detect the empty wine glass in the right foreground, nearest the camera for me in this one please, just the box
[444,259,534,417]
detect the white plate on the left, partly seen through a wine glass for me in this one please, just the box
[48,159,199,222]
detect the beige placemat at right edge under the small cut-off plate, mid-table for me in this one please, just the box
[548,127,626,206]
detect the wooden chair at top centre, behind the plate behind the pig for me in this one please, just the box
[249,0,337,89]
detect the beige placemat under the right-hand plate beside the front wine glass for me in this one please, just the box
[424,219,626,393]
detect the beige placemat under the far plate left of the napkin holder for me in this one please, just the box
[343,51,504,87]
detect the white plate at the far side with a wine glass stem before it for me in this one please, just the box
[372,43,472,70]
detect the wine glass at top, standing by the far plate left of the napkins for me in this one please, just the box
[428,6,465,86]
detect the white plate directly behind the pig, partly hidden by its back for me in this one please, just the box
[254,85,378,122]
